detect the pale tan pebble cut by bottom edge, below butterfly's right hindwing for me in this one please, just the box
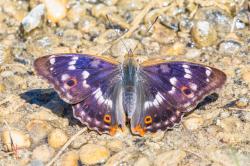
[154,150,186,166]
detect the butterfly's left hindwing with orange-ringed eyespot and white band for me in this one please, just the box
[73,82,126,135]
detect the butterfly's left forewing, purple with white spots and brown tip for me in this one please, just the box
[34,54,119,104]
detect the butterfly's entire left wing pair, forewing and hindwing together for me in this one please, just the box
[34,54,125,135]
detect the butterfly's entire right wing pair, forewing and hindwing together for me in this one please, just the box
[131,61,226,135]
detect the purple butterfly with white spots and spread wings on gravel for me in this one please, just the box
[34,54,226,136]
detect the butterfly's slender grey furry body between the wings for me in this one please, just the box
[122,58,138,118]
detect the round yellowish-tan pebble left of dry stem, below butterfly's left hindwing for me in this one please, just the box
[48,129,68,148]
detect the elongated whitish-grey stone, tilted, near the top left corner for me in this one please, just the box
[22,4,45,32]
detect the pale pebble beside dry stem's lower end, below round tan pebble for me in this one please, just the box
[32,145,55,162]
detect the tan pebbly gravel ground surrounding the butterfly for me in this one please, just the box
[0,0,250,166]
